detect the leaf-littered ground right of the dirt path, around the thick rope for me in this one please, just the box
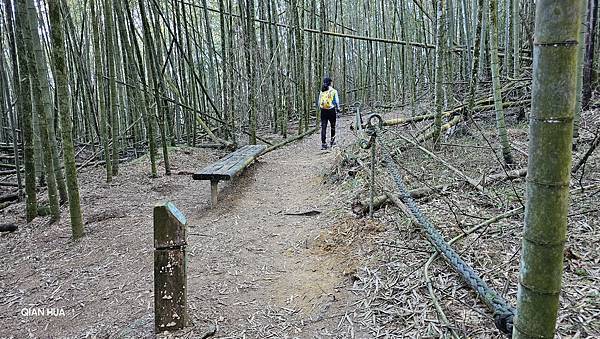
[332,107,600,338]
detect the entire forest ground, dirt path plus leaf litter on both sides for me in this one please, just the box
[0,111,600,338]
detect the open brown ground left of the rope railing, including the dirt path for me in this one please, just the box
[0,116,354,338]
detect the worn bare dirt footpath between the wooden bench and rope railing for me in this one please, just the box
[184,117,356,337]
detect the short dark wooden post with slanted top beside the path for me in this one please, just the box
[154,202,188,333]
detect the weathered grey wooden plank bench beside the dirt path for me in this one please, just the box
[192,145,267,207]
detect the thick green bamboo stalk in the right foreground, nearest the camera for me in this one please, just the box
[513,0,583,339]
